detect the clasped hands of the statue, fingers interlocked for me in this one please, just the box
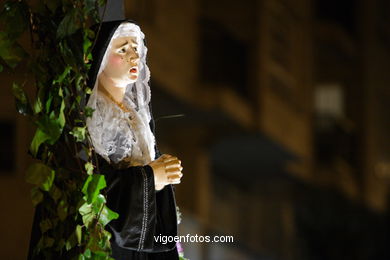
[149,154,183,190]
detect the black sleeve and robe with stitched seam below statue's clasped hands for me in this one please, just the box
[99,156,177,252]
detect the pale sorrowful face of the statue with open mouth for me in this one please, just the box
[103,36,139,83]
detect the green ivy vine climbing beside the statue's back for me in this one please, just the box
[0,0,118,259]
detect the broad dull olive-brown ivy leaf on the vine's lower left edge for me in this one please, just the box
[26,163,55,191]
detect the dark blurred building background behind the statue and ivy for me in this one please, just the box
[0,0,390,259]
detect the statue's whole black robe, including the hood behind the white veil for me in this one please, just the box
[28,21,179,260]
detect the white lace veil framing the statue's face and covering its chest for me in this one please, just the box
[87,22,155,165]
